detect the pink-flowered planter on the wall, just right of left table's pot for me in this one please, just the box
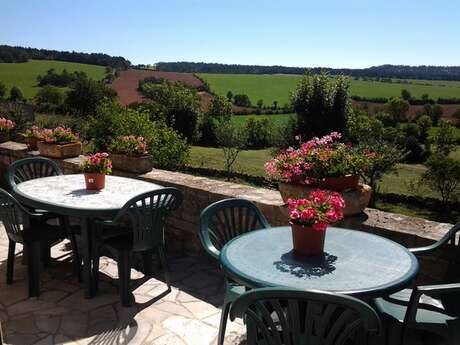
[109,135,153,174]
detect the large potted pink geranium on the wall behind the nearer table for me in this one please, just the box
[265,132,374,202]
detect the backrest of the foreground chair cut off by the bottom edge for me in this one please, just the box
[230,288,382,345]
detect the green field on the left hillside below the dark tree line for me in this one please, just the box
[0,60,105,98]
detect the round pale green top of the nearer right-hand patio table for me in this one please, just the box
[220,226,418,300]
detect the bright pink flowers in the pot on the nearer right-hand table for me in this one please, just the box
[288,189,345,231]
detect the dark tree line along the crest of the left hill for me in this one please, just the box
[0,45,131,69]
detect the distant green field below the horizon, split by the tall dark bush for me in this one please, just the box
[198,73,460,105]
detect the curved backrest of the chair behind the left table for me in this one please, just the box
[5,157,62,188]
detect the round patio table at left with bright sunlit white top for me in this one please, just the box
[13,174,163,298]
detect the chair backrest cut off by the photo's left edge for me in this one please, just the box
[0,188,29,243]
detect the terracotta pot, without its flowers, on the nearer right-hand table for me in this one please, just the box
[291,224,326,257]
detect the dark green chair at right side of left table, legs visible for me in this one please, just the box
[94,188,182,306]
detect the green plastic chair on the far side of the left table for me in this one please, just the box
[5,157,81,279]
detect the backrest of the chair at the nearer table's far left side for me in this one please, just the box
[200,199,270,259]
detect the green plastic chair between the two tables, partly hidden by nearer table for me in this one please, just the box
[200,199,270,345]
